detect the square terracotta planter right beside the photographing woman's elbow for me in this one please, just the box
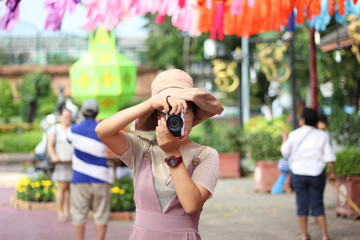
[219,153,240,178]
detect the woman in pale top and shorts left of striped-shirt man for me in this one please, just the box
[47,109,73,222]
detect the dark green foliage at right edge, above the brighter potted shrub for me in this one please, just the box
[329,108,360,147]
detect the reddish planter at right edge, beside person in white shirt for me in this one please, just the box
[335,176,360,218]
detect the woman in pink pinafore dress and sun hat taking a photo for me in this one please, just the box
[96,69,223,240]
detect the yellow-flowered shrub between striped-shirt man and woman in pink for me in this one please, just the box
[110,176,135,212]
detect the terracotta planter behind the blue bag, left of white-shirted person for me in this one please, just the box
[254,161,291,192]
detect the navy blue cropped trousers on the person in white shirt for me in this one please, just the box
[291,170,326,217]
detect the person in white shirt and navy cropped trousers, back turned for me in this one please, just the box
[281,108,336,240]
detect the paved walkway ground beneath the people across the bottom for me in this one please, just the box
[0,172,360,240]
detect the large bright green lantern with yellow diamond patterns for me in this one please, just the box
[70,27,136,120]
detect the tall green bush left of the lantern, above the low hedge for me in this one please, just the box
[20,72,56,122]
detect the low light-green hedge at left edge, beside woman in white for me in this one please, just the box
[0,129,42,153]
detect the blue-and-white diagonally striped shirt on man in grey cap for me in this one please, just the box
[67,119,112,183]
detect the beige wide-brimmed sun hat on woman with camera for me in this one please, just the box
[135,69,224,131]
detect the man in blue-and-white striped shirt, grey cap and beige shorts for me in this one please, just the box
[68,99,112,240]
